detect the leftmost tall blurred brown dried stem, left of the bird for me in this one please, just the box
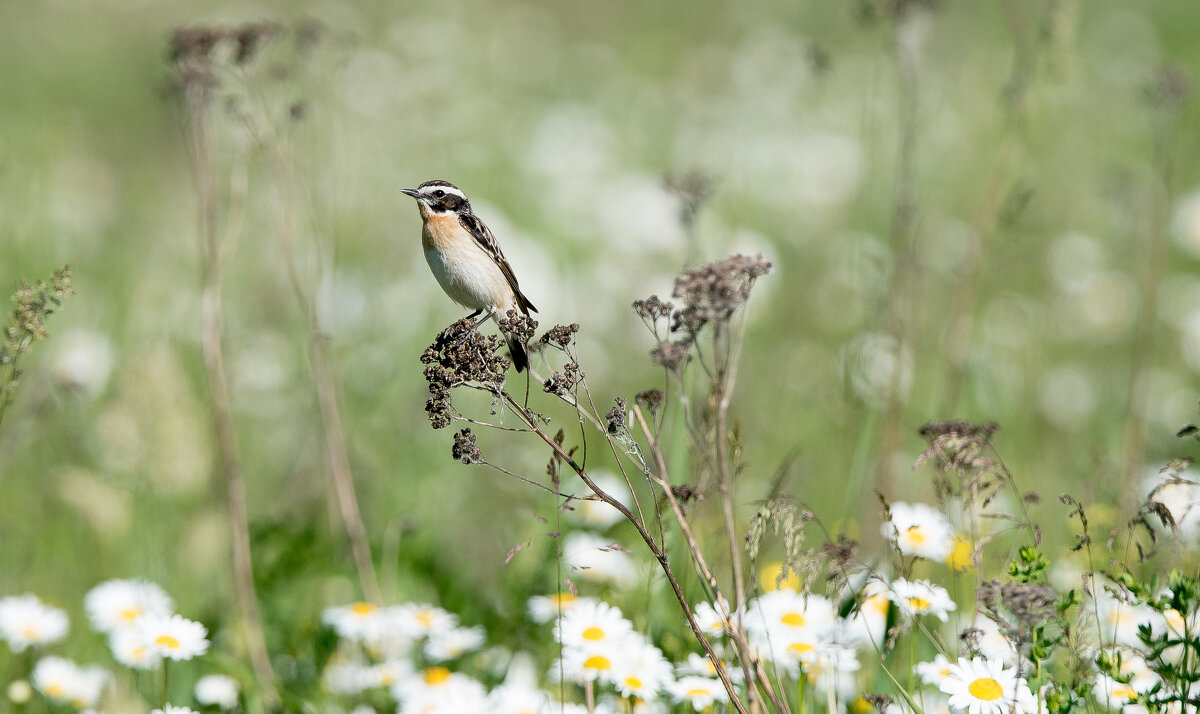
[186,79,280,709]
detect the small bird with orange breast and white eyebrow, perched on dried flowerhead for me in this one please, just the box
[401,181,538,372]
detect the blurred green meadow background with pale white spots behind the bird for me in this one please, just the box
[0,0,1200,686]
